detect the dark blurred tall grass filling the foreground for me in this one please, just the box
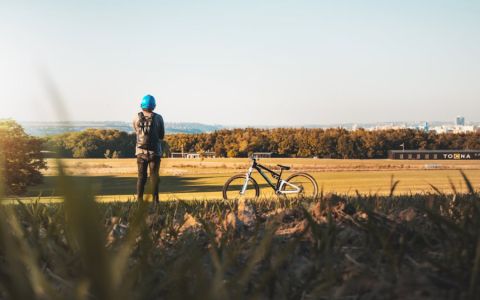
[0,165,480,300]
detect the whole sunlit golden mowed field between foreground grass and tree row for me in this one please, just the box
[17,158,480,201]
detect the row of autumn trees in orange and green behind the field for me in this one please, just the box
[44,128,480,159]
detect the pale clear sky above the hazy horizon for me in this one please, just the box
[0,0,480,125]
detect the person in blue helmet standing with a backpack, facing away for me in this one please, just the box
[133,95,165,202]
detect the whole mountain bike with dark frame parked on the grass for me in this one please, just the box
[223,157,318,200]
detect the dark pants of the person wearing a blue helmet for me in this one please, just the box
[137,154,160,201]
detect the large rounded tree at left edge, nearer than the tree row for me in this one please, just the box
[0,120,46,195]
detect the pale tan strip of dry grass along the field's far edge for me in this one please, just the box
[45,158,480,175]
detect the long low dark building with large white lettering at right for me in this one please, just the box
[389,150,480,160]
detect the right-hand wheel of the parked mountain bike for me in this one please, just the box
[281,173,318,198]
